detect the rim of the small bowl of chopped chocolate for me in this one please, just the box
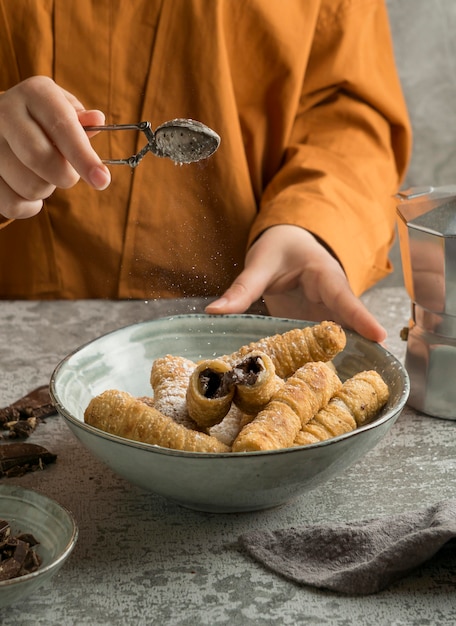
[0,484,79,594]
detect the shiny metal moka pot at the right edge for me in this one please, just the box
[397,185,456,419]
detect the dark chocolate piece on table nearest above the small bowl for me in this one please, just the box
[0,443,57,478]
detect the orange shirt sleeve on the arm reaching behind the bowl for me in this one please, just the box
[250,0,411,295]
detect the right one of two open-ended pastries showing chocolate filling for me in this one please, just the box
[233,350,283,414]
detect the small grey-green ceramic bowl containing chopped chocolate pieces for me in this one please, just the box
[0,484,78,608]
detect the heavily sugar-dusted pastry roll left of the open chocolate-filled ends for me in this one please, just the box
[150,354,196,428]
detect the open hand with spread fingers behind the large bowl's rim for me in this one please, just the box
[206,225,386,342]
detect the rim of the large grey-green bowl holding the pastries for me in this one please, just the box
[49,313,410,459]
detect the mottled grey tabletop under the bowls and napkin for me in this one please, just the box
[0,287,456,626]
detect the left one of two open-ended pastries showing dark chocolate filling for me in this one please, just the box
[186,359,234,428]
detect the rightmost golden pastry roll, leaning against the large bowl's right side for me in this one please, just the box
[294,370,389,446]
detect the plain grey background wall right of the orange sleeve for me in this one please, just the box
[381,0,456,286]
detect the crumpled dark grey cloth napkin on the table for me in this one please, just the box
[240,500,456,595]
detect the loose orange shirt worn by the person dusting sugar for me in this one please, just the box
[0,0,410,299]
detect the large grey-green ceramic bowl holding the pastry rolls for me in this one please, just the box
[50,315,409,512]
